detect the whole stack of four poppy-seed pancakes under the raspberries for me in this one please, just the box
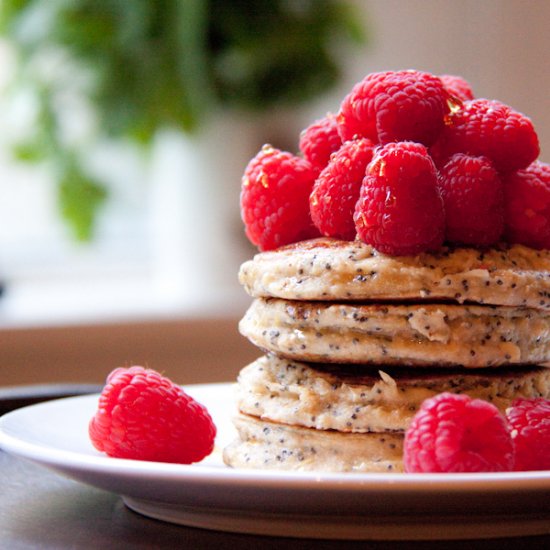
[224,238,550,472]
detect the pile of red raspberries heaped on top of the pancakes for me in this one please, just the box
[241,70,550,256]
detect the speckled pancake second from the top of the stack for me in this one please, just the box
[243,298,550,368]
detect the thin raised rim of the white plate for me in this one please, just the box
[0,382,550,493]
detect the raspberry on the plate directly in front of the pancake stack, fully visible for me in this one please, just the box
[403,393,514,473]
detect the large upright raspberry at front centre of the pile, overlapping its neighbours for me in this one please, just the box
[354,142,445,256]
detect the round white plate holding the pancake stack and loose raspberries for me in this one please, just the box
[0,384,550,540]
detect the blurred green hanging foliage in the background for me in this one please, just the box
[0,0,364,239]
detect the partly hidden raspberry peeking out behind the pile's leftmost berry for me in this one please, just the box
[300,113,342,172]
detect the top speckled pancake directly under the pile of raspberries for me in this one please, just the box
[239,238,550,310]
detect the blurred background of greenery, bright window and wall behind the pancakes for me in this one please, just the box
[0,0,550,385]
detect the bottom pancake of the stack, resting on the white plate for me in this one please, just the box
[223,414,403,472]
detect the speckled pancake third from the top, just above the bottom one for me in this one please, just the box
[237,355,550,432]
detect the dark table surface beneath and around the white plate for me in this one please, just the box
[0,388,550,550]
